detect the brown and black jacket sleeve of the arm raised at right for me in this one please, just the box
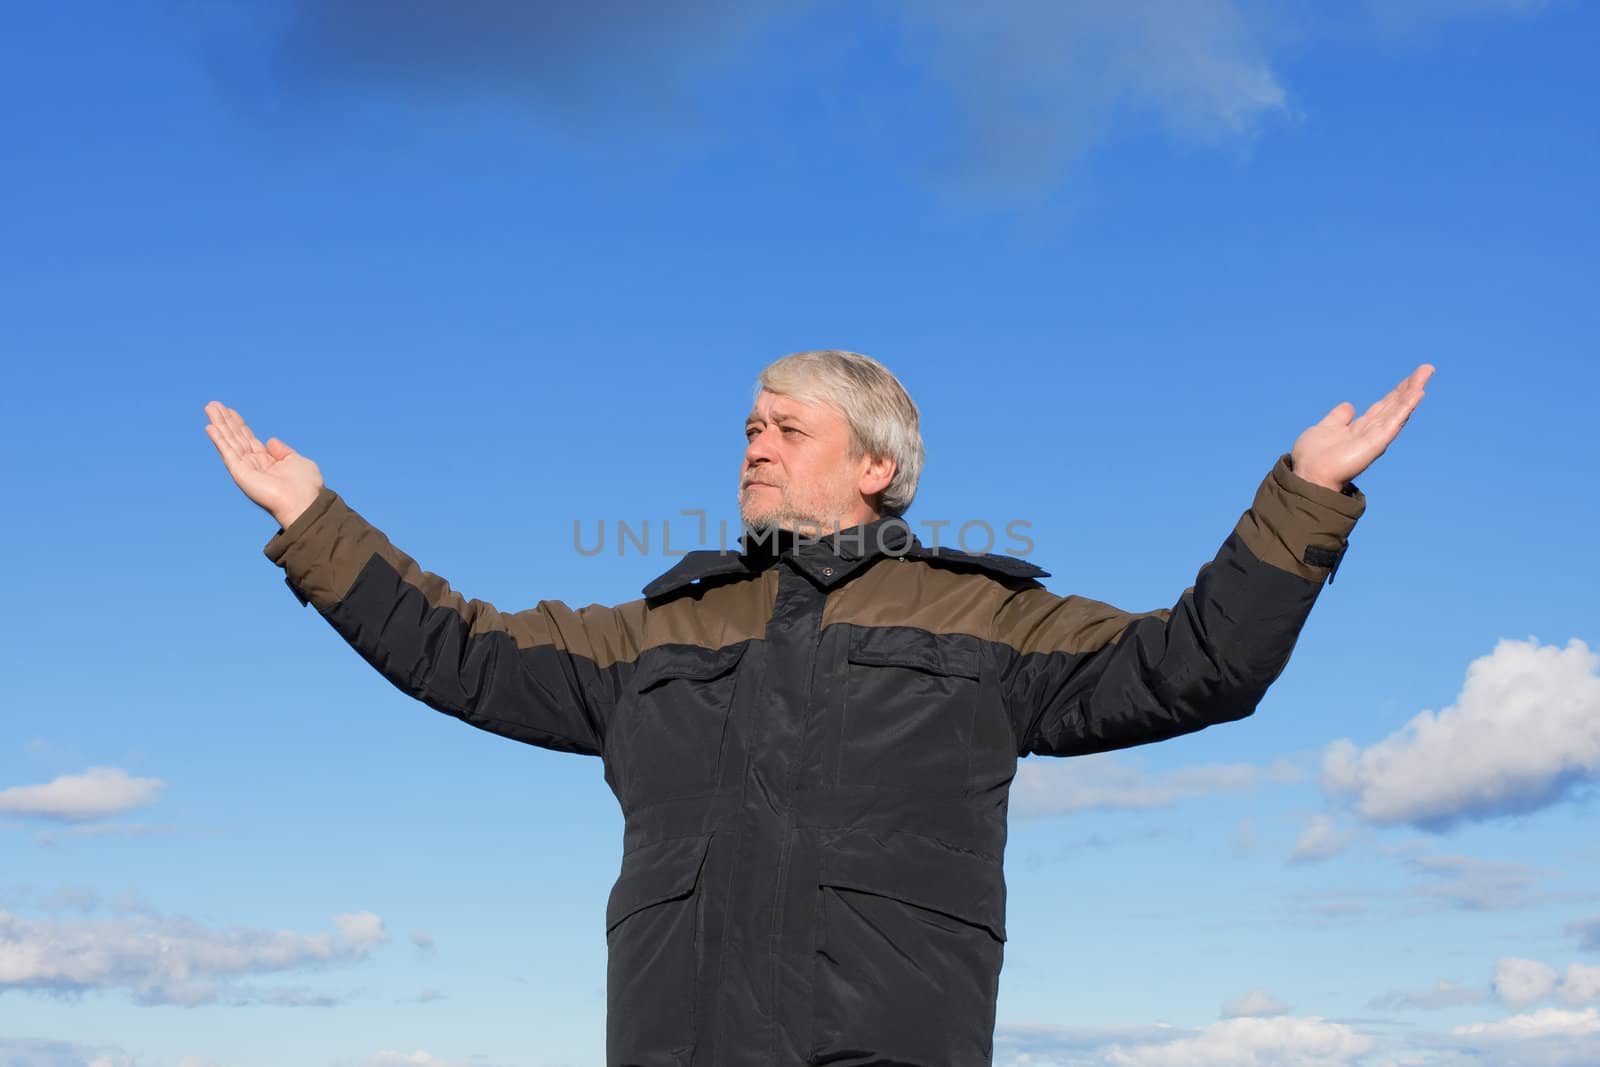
[995,453,1366,755]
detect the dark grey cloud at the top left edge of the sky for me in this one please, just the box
[192,0,794,136]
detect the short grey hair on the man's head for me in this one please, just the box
[755,349,923,515]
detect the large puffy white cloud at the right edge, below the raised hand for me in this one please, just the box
[1322,638,1600,830]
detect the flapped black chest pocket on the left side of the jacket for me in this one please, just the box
[619,641,749,805]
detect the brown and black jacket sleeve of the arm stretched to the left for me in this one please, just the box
[262,486,637,755]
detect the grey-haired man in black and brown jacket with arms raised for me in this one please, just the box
[206,350,1434,1067]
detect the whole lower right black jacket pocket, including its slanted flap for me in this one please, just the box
[810,830,1005,1067]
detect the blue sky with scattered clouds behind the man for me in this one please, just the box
[0,0,1600,1067]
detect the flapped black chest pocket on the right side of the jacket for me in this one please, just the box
[834,625,982,797]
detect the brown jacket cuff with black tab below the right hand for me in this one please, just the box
[1235,453,1366,582]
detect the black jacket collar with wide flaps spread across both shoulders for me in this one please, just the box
[643,517,1050,600]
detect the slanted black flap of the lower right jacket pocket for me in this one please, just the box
[818,830,1005,941]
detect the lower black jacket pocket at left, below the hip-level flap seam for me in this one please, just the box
[605,835,710,1067]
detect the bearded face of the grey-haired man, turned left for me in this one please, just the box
[739,389,893,533]
